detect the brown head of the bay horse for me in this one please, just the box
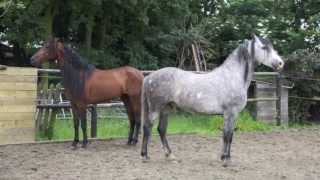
[30,38,64,67]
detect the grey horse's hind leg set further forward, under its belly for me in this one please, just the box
[158,112,171,157]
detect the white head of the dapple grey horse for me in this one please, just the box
[251,35,284,70]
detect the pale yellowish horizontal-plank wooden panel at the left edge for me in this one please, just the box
[0,67,37,144]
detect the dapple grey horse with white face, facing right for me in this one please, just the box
[141,35,284,166]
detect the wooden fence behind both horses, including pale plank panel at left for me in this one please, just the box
[0,67,283,144]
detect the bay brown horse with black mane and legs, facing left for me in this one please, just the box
[31,38,144,147]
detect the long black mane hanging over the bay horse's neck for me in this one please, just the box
[61,47,95,99]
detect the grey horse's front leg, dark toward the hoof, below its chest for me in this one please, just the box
[221,112,236,166]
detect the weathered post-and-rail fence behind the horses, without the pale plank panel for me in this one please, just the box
[37,69,287,139]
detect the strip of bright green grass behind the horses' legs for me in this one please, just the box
[37,111,273,140]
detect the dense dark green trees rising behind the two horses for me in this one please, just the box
[0,0,320,69]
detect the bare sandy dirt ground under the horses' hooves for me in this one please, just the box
[0,127,320,180]
